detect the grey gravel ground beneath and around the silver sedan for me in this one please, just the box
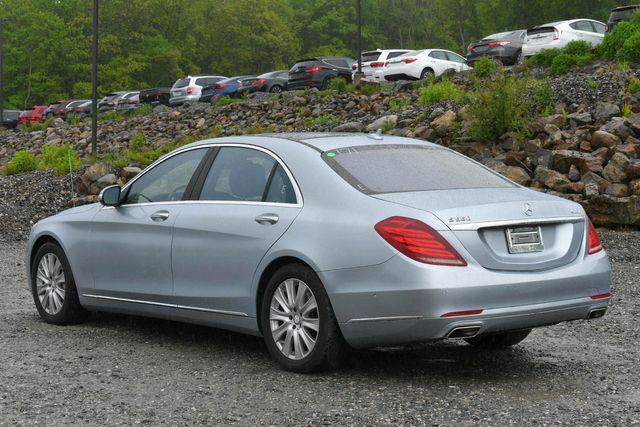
[0,232,640,425]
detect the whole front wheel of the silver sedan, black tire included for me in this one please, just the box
[31,242,88,325]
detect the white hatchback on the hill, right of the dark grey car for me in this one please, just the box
[522,19,606,58]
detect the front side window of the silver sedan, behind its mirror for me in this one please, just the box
[124,148,208,205]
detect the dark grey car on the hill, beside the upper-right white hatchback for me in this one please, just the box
[467,30,527,65]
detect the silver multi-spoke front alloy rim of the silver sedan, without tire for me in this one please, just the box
[36,253,66,316]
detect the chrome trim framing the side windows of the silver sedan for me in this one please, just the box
[112,142,304,209]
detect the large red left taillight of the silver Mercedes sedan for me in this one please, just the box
[375,216,467,267]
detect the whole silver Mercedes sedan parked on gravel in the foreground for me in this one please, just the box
[26,133,610,372]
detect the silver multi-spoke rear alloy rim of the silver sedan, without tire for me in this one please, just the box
[269,279,320,360]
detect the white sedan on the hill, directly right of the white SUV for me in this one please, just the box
[384,49,471,81]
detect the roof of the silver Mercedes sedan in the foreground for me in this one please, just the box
[180,132,440,152]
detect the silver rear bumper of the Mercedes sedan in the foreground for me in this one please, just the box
[318,252,611,347]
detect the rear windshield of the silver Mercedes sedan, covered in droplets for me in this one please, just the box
[323,144,513,194]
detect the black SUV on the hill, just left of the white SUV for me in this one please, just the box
[287,56,355,90]
